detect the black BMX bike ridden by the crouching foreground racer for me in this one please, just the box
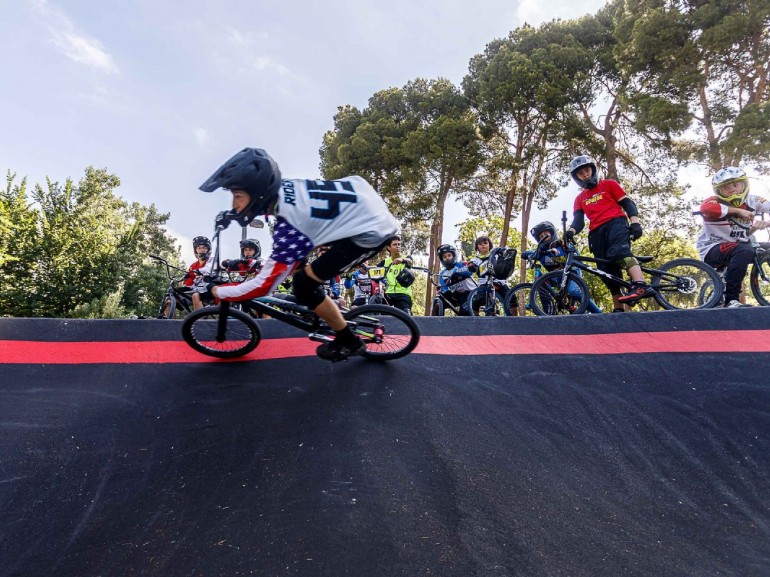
[182,223,420,361]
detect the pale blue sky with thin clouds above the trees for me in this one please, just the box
[0,0,764,262]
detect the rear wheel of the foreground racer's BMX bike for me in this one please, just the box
[344,305,420,361]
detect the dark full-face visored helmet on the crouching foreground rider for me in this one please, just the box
[200,148,281,226]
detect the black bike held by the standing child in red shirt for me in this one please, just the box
[530,236,722,316]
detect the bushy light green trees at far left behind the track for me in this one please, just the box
[0,167,179,317]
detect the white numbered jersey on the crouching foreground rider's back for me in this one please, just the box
[276,176,398,248]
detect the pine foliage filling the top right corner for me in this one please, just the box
[615,0,770,170]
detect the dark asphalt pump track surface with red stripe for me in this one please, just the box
[0,308,770,577]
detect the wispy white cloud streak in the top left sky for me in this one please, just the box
[32,0,118,73]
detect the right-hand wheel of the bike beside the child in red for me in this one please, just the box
[652,258,724,310]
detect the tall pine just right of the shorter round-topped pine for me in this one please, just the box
[463,25,590,250]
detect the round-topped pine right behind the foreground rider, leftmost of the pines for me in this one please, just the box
[321,79,474,316]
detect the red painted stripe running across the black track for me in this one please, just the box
[0,330,770,365]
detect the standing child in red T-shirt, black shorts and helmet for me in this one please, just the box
[564,156,655,312]
